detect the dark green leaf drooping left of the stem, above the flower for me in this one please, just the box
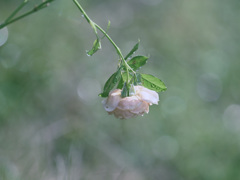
[99,69,121,97]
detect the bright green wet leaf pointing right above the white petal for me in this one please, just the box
[141,74,167,92]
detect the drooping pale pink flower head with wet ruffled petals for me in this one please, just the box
[102,86,159,119]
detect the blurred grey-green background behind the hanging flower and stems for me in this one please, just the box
[0,0,240,180]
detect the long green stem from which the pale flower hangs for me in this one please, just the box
[73,0,135,84]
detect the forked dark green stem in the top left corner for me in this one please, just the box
[0,0,53,29]
